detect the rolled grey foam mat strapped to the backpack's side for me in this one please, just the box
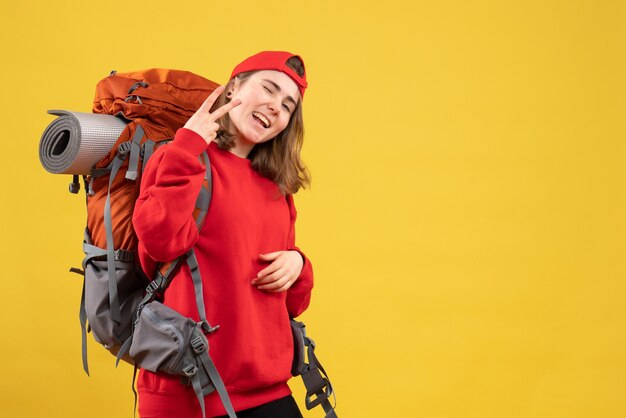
[39,110,126,175]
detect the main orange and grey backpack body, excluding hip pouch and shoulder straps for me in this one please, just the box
[72,69,218,374]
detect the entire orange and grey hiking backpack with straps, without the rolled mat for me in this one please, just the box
[50,69,336,418]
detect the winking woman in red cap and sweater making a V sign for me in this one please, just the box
[133,51,313,418]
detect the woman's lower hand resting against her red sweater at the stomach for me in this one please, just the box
[252,251,304,292]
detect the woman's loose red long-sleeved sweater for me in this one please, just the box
[133,129,313,418]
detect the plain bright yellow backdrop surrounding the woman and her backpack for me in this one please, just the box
[0,0,626,418]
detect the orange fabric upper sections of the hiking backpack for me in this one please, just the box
[87,69,219,251]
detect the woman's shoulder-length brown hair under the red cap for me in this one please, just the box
[211,56,311,194]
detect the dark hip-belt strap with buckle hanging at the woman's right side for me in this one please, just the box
[293,321,337,418]
